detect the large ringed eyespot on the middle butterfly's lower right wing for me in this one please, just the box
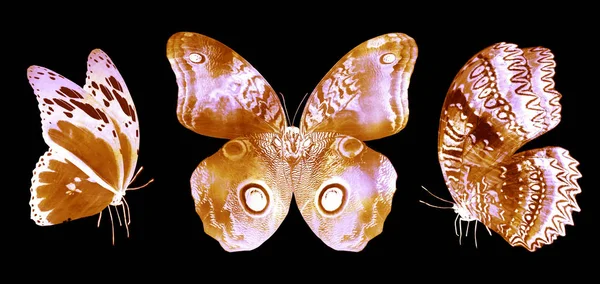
[315,180,348,217]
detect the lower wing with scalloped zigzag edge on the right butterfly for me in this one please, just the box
[469,147,581,251]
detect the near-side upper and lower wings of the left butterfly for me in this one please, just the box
[27,50,137,225]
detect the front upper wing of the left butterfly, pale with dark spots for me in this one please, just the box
[27,66,123,191]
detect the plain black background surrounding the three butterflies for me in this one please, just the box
[14,5,598,274]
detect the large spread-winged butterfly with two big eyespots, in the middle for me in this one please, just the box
[167,32,417,252]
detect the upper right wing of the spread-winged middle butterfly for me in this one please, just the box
[300,33,417,141]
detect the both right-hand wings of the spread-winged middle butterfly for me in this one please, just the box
[294,33,417,251]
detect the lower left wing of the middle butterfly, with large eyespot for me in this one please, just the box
[191,133,292,252]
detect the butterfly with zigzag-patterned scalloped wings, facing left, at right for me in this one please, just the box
[428,42,581,251]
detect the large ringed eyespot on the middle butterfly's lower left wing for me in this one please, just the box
[238,181,271,217]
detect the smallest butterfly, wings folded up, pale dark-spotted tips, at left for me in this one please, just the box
[27,49,153,243]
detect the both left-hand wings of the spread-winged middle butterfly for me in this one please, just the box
[167,32,292,251]
